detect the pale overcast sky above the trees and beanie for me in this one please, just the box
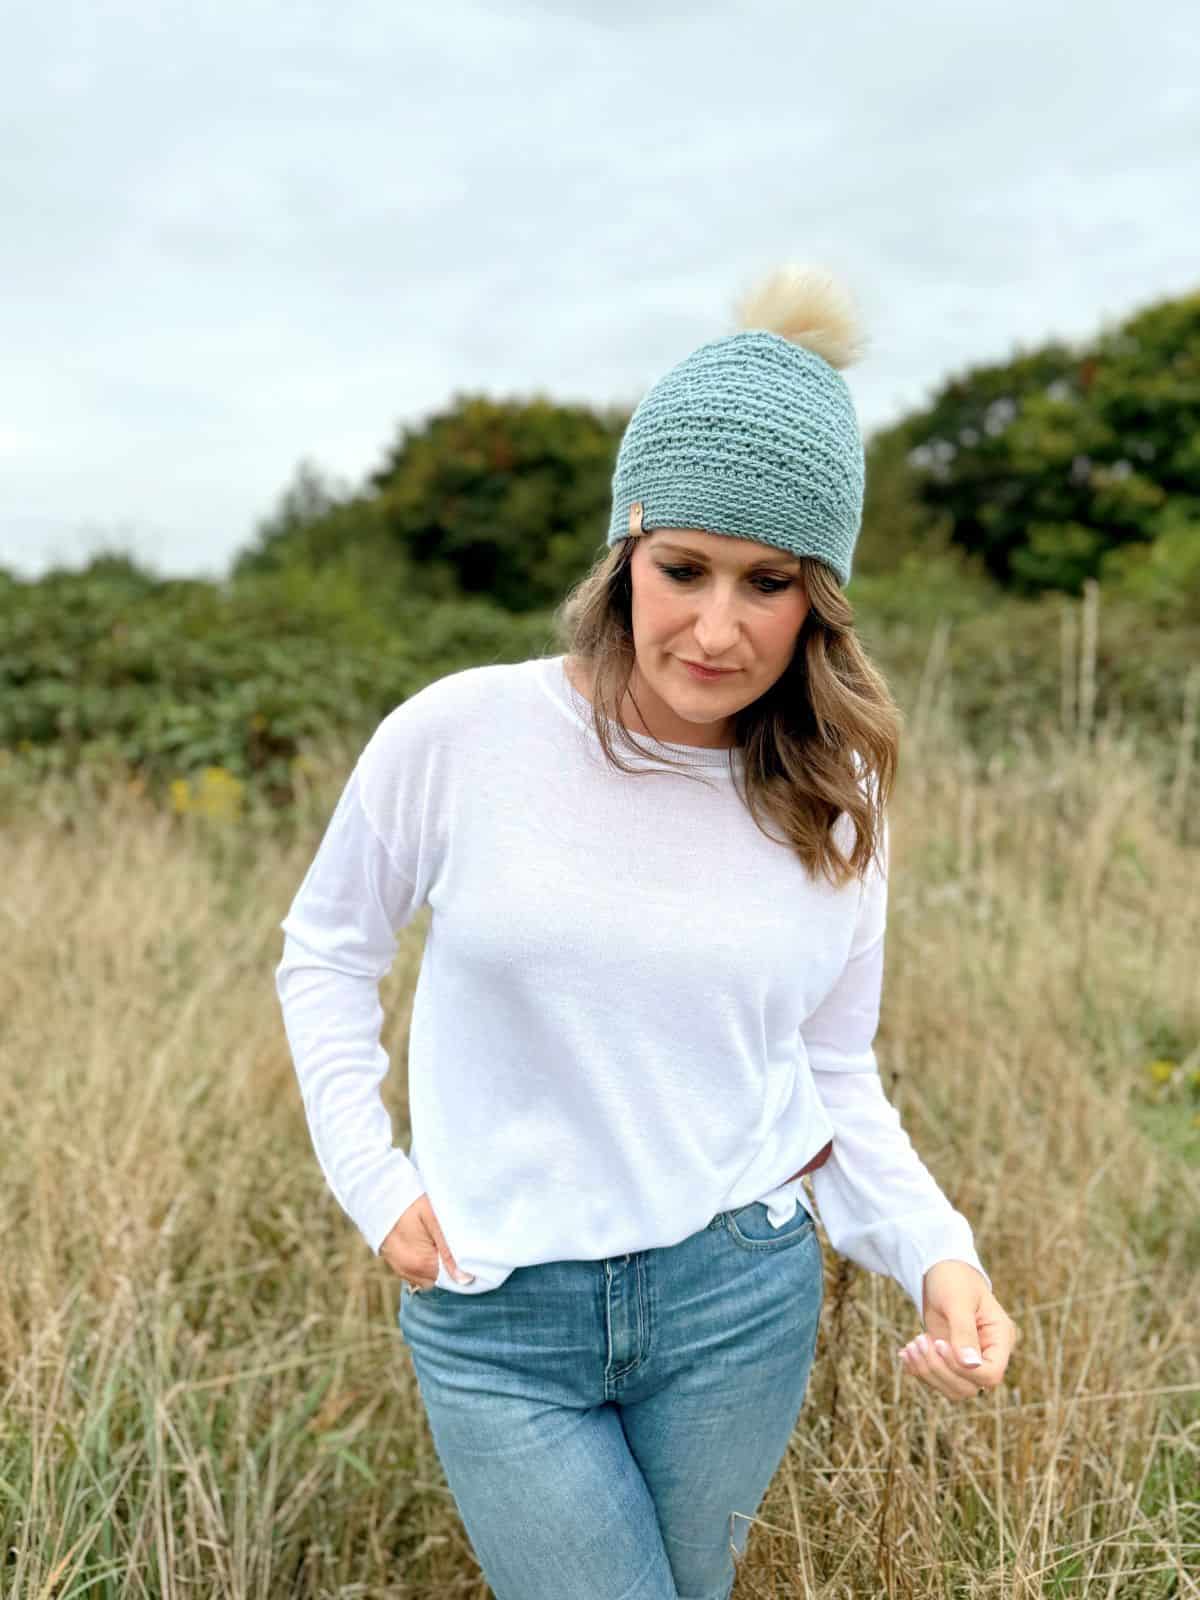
[0,0,1200,576]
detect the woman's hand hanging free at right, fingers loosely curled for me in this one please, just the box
[899,1261,1021,1400]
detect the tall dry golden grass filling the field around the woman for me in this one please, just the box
[0,603,1200,1600]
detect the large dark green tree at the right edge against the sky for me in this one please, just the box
[904,293,1200,594]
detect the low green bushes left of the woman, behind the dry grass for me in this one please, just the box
[0,568,549,805]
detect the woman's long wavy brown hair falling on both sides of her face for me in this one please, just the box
[554,534,902,888]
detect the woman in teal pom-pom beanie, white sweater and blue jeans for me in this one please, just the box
[277,270,1016,1600]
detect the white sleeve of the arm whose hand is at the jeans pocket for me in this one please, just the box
[275,755,426,1251]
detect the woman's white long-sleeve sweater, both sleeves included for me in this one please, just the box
[275,643,990,1315]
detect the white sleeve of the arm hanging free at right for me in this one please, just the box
[800,821,992,1320]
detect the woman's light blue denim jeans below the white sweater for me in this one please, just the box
[398,1200,824,1600]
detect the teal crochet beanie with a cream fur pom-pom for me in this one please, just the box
[608,267,864,587]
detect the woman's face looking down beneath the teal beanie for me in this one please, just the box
[630,528,808,749]
